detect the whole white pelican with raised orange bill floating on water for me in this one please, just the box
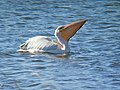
[18,20,86,54]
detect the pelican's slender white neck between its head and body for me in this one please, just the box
[55,33,69,51]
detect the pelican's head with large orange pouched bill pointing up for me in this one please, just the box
[55,20,86,42]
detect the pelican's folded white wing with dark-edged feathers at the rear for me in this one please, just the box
[19,36,58,51]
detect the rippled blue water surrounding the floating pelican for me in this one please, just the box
[0,0,120,90]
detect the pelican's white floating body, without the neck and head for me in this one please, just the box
[19,36,70,53]
